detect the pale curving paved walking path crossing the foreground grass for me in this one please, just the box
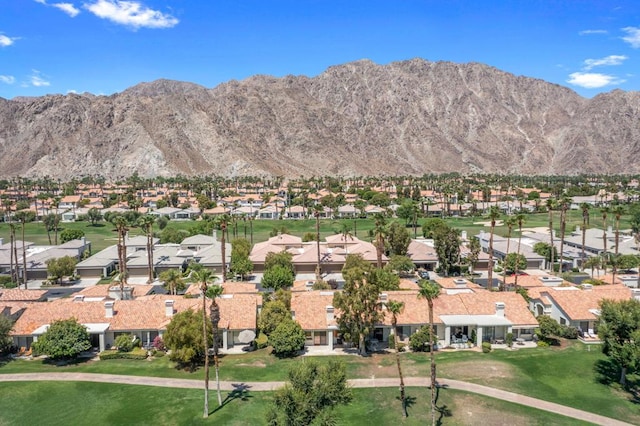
[0,373,630,426]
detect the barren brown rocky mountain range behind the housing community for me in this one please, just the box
[0,59,640,179]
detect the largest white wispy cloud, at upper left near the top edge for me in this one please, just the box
[84,0,179,29]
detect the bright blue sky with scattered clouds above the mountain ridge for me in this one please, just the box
[0,0,640,99]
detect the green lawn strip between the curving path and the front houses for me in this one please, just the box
[0,342,640,424]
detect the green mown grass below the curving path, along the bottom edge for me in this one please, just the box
[0,382,584,426]
